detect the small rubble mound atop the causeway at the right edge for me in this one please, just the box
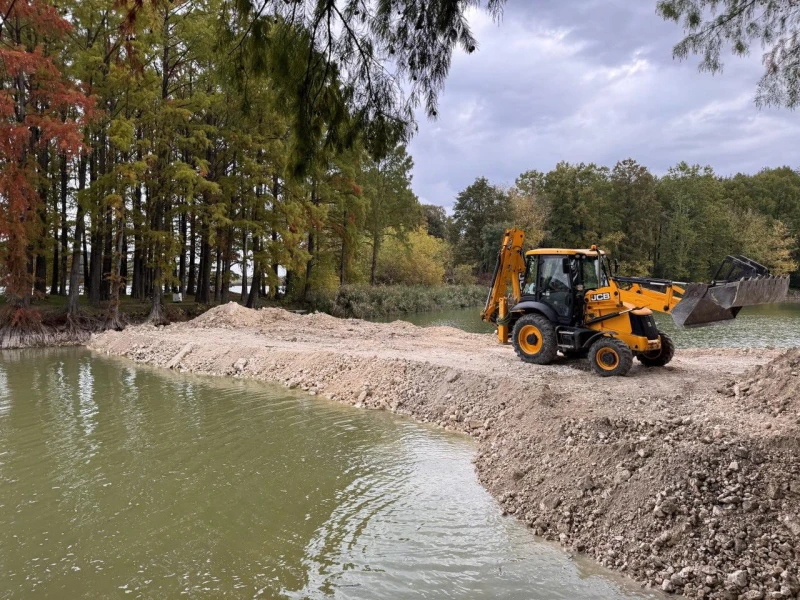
[727,348,800,422]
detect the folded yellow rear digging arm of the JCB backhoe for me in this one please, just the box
[481,229,525,343]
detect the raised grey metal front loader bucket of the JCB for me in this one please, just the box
[672,256,789,327]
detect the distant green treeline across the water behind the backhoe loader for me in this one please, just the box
[444,159,800,285]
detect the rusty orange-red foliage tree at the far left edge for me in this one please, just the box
[0,0,94,309]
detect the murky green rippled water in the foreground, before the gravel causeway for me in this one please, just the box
[0,349,656,599]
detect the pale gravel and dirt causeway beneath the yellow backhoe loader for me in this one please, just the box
[89,304,800,599]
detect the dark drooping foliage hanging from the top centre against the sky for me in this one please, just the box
[219,0,505,166]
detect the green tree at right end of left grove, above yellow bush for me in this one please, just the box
[362,145,422,285]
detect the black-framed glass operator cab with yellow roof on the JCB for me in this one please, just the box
[521,248,608,325]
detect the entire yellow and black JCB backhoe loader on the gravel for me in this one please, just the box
[482,229,789,376]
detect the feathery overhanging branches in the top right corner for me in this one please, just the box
[657,0,800,108]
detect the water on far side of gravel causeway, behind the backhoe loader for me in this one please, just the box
[376,303,800,348]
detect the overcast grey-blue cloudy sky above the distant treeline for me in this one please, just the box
[409,0,800,209]
